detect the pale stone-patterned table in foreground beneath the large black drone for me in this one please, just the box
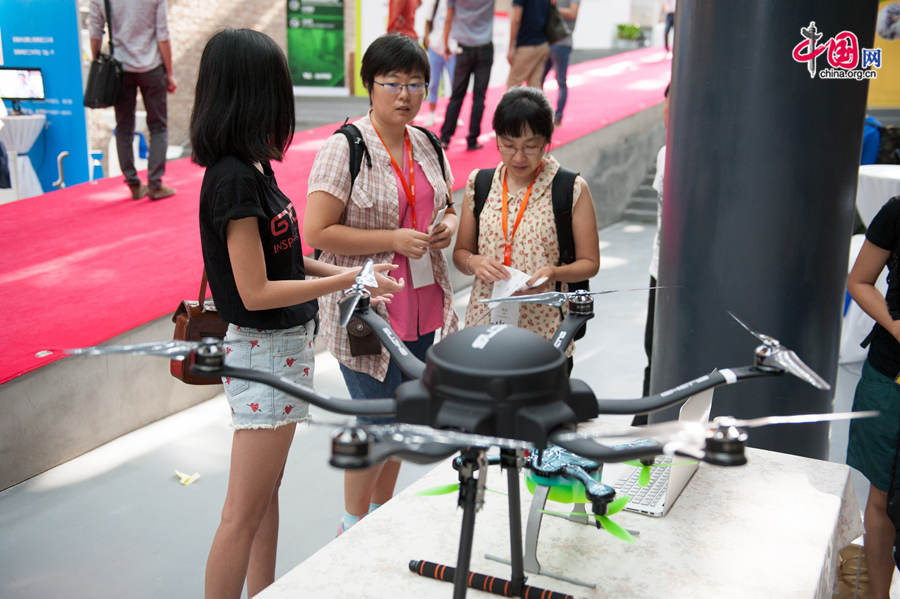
[259,442,862,599]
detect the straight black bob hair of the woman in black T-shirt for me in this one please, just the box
[190,29,295,166]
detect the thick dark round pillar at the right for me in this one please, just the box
[651,0,877,458]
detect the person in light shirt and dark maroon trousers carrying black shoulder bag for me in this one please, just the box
[88,0,177,200]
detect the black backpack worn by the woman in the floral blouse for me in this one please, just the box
[472,167,590,291]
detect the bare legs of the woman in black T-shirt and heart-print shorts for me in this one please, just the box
[205,424,296,599]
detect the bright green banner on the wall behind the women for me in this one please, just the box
[287,0,346,88]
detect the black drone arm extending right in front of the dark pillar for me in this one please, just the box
[597,366,784,414]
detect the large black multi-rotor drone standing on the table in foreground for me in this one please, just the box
[66,260,877,599]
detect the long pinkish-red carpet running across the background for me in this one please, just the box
[0,48,670,383]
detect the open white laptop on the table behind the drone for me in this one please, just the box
[603,389,714,517]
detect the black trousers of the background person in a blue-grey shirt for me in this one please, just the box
[441,43,494,146]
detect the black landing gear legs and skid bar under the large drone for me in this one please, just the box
[409,449,574,599]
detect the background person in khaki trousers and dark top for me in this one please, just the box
[506,0,550,89]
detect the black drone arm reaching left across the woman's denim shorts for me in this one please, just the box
[211,364,397,416]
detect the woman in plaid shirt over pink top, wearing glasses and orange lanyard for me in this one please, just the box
[303,35,458,534]
